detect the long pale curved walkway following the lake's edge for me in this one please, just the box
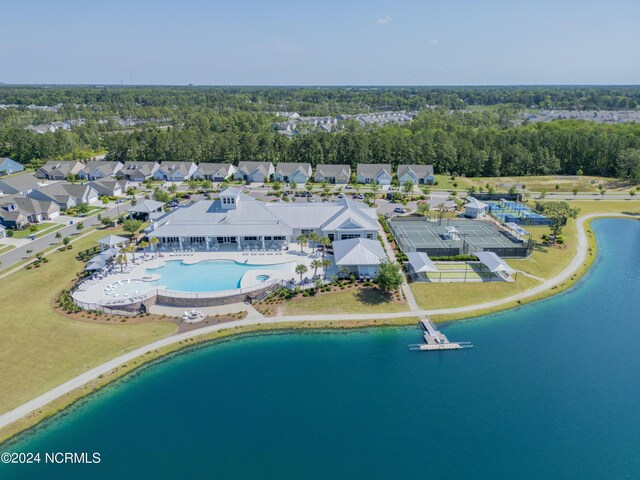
[0,213,636,428]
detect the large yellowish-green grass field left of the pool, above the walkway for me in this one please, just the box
[0,230,176,413]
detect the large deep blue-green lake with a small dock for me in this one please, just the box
[0,220,640,480]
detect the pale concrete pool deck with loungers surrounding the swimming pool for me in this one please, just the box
[74,246,321,303]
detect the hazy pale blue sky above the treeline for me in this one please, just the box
[0,0,640,85]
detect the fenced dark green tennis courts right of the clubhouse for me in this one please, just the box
[389,217,530,257]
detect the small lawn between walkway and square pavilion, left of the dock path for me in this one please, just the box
[280,288,408,315]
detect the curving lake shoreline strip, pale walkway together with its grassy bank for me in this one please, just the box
[0,213,638,444]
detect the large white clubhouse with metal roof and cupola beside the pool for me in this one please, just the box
[147,187,378,251]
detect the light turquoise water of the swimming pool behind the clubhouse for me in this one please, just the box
[147,260,291,292]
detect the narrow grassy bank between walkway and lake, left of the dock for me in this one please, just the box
[0,317,417,444]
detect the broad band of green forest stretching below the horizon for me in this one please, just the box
[0,86,640,182]
